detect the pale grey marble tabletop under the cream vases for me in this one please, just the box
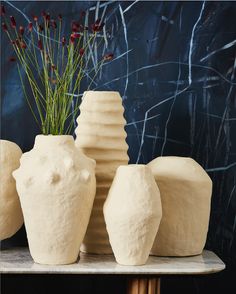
[0,248,225,275]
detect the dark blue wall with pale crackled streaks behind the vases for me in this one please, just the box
[1,1,236,293]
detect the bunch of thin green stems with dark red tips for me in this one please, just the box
[1,5,113,135]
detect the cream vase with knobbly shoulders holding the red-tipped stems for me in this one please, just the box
[13,135,96,264]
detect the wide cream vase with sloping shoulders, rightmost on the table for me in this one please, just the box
[148,156,212,256]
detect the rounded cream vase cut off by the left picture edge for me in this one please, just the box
[0,140,23,240]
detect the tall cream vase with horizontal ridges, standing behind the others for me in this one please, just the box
[76,91,128,254]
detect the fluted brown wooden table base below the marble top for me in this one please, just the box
[127,276,161,294]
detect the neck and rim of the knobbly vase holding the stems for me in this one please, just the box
[34,134,74,147]
